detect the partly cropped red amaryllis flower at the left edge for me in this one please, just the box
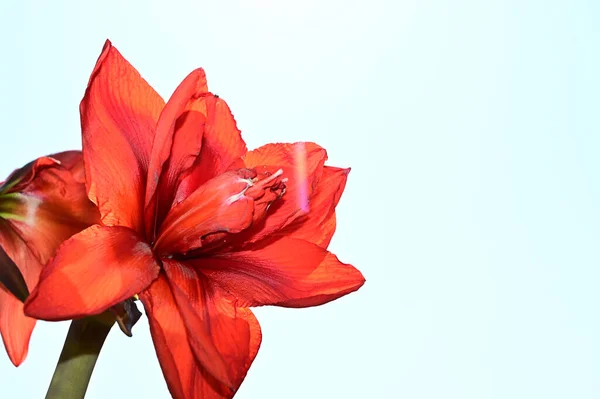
[0,151,99,366]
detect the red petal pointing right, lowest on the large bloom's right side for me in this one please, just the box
[195,237,365,307]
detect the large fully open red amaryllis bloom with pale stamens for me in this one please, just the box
[26,42,364,399]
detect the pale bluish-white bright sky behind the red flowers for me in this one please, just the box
[0,0,600,399]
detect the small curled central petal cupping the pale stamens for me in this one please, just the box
[155,170,254,255]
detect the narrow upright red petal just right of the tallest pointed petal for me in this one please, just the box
[146,69,212,238]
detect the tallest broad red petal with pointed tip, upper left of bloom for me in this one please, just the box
[80,41,164,233]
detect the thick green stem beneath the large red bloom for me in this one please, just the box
[46,313,115,399]
